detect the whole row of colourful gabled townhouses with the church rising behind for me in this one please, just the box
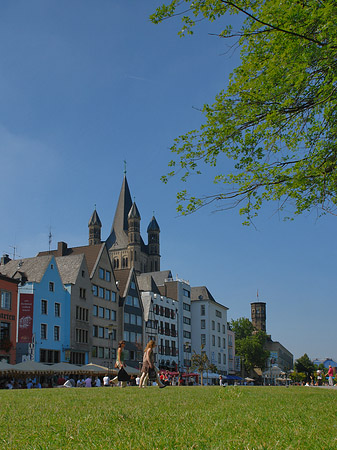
[0,177,235,374]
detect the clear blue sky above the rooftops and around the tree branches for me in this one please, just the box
[0,0,337,359]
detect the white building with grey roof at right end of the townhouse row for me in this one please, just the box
[191,286,228,375]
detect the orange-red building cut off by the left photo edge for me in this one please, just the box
[0,274,19,364]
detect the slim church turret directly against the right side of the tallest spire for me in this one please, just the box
[126,202,141,273]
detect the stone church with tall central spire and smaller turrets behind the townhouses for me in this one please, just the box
[88,175,160,274]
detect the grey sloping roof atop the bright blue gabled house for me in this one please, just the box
[0,255,53,283]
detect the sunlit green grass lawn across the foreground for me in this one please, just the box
[0,387,337,450]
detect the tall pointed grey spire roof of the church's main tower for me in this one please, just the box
[106,175,132,250]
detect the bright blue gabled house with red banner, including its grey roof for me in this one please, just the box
[0,255,70,363]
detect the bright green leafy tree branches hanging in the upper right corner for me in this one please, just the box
[151,0,337,224]
